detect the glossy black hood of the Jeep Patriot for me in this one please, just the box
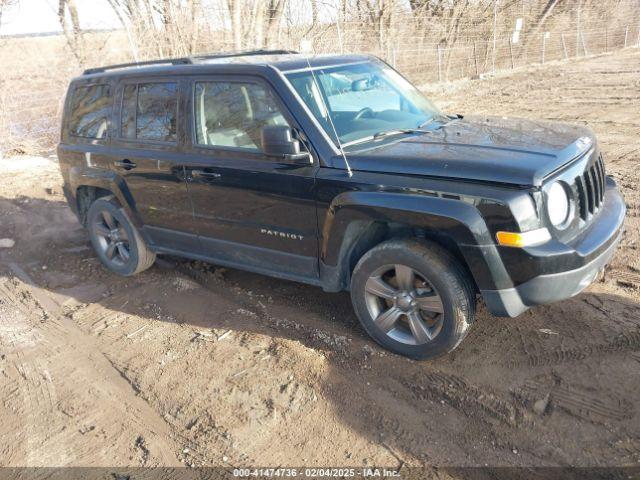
[347,117,596,186]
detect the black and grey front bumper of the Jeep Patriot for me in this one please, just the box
[481,180,626,317]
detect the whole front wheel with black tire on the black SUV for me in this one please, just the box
[351,240,476,360]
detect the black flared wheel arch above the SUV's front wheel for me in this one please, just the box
[320,192,506,291]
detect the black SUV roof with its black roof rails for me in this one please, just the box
[83,50,371,77]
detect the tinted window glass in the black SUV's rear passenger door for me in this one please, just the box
[120,82,178,142]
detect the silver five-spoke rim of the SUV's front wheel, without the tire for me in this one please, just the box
[365,264,444,345]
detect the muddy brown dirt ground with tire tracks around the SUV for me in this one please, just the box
[0,49,640,475]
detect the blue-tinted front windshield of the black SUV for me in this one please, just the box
[287,62,442,146]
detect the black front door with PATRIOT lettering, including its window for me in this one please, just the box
[185,77,318,281]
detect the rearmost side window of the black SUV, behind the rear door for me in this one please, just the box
[69,85,112,139]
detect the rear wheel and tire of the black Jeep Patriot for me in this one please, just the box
[87,195,156,277]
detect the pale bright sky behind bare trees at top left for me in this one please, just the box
[0,0,120,35]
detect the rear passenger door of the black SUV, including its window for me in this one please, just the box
[111,78,199,252]
